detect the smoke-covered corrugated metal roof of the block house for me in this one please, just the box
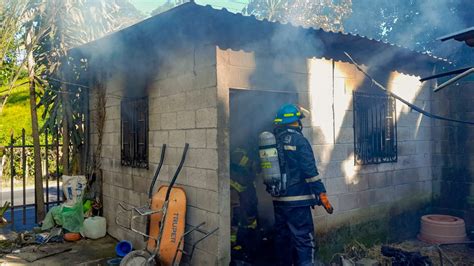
[75,3,447,73]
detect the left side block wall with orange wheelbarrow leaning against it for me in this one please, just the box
[90,45,220,265]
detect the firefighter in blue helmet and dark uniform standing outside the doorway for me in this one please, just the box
[273,104,333,266]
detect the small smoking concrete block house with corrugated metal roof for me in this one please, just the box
[68,3,468,265]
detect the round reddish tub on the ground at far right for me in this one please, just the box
[418,214,467,244]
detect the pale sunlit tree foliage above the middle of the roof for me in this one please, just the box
[242,0,352,31]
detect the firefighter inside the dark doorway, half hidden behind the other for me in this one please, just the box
[230,148,258,262]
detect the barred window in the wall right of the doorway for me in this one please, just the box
[353,92,397,165]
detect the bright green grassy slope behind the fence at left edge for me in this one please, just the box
[0,79,44,146]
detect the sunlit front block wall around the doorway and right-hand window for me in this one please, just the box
[217,49,433,239]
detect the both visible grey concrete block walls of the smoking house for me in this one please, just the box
[90,45,433,265]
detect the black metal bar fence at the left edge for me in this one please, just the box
[0,129,62,229]
